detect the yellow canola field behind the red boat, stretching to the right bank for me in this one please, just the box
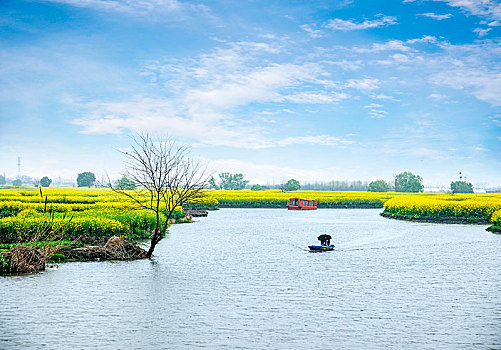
[209,190,501,227]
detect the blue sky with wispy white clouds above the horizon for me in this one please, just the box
[0,0,501,187]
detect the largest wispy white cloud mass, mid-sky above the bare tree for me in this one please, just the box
[73,41,352,149]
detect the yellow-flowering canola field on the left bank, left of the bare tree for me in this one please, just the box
[0,188,189,243]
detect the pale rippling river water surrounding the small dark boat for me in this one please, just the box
[0,209,501,349]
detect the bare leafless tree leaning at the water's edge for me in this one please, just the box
[110,133,211,258]
